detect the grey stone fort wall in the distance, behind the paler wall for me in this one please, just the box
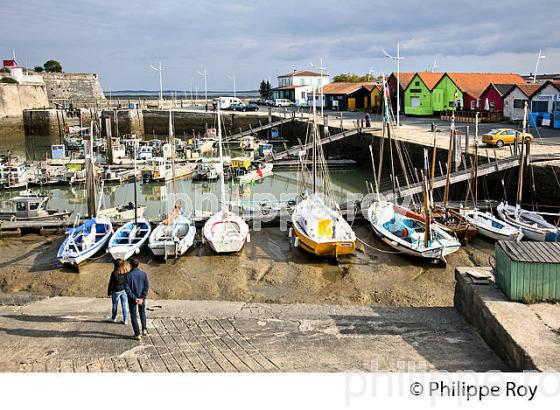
[43,73,105,106]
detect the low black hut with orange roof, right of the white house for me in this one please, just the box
[316,82,379,111]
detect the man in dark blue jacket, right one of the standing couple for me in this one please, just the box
[124,256,150,340]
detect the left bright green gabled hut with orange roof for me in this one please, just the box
[404,71,443,116]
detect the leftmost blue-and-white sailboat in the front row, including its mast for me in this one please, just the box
[56,122,113,266]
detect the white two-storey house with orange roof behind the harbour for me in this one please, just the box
[272,70,330,106]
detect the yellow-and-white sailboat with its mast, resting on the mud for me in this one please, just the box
[291,90,356,257]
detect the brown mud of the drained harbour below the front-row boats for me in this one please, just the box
[0,225,494,307]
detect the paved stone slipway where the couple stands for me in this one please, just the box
[0,297,505,372]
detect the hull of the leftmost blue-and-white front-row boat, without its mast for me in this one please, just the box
[56,218,113,266]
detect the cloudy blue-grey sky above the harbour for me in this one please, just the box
[0,0,560,91]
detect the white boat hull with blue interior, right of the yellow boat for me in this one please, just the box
[367,201,461,260]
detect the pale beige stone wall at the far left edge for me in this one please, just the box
[0,84,49,118]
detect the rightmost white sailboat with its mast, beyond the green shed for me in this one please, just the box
[496,102,560,242]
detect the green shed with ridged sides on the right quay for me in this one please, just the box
[496,241,560,302]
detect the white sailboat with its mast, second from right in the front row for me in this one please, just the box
[459,113,523,241]
